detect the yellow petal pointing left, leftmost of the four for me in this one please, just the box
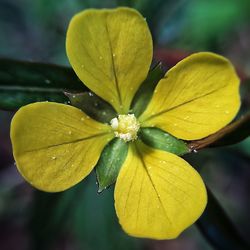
[11,102,112,192]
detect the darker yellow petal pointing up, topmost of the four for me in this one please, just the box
[66,7,153,114]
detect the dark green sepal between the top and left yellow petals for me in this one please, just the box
[65,92,117,123]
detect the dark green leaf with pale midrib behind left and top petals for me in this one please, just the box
[0,59,87,110]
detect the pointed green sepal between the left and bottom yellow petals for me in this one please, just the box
[95,138,129,193]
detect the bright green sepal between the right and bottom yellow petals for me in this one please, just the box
[139,128,190,155]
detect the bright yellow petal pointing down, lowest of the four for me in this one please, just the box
[115,143,207,239]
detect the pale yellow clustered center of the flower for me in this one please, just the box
[110,114,140,142]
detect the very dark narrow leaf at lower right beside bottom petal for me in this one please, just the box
[196,187,250,250]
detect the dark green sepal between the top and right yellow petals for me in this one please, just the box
[130,63,165,117]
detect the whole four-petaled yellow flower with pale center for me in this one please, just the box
[11,8,240,239]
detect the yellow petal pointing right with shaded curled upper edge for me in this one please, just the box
[140,52,240,140]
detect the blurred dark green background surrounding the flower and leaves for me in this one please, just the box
[0,0,250,250]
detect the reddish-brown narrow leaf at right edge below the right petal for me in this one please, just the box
[188,114,250,151]
